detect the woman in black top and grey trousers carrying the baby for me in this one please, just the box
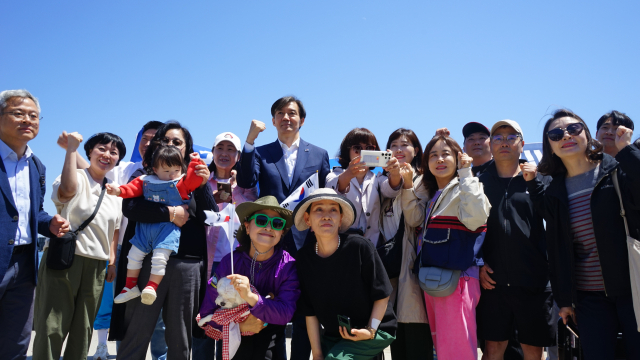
[111,121,218,359]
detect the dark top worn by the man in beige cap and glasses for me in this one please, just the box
[479,161,551,287]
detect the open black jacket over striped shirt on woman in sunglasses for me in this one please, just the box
[527,146,640,307]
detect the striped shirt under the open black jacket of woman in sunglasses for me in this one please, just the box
[565,167,604,291]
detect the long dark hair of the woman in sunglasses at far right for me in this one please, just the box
[538,109,602,177]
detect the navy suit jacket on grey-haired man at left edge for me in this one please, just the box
[0,155,51,283]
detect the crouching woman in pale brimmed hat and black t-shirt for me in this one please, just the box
[293,188,396,360]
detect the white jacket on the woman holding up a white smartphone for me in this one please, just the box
[325,167,402,246]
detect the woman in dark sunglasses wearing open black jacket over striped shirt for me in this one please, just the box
[522,109,640,359]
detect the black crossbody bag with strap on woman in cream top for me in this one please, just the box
[47,178,107,270]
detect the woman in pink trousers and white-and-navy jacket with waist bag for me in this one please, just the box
[403,135,491,360]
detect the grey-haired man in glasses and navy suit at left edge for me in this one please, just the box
[0,90,69,359]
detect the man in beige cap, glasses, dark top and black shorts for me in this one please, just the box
[476,120,555,360]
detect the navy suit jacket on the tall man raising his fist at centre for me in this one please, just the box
[236,139,330,257]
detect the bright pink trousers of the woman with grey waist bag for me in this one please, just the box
[424,277,480,360]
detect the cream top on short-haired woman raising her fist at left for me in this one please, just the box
[50,169,122,260]
